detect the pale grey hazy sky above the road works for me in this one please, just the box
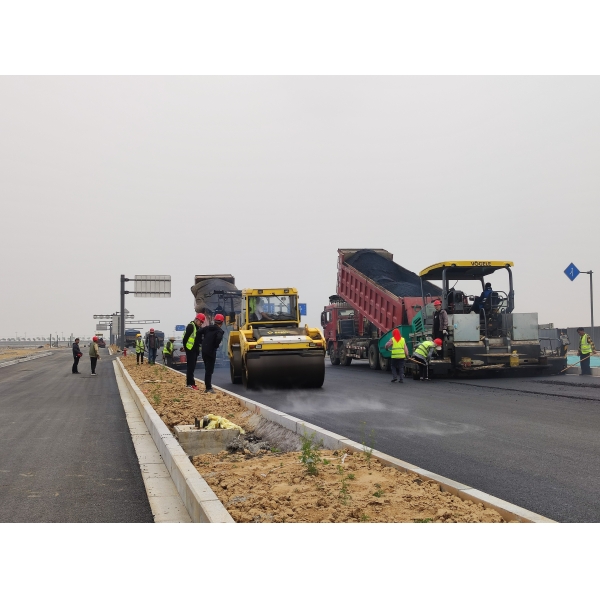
[0,76,600,337]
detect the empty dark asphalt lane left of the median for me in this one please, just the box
[0,348,153,523]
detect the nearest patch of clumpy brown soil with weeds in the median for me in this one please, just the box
[193,449,505,523]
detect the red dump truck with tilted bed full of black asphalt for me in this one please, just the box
[321,248,441,370]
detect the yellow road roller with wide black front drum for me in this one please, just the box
[227,288,325,389]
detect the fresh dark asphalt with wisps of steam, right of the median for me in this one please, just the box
[205,362,600,522]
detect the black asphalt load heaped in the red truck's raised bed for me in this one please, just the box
[346,250,442,298]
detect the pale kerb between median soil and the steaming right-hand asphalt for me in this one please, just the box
[150,369,555,523]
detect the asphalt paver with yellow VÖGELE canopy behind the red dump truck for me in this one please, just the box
[419,261,566,375]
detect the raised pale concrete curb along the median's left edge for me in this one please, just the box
[115,358,235,523]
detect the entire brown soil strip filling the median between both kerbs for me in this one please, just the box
[121,357,504,523]
